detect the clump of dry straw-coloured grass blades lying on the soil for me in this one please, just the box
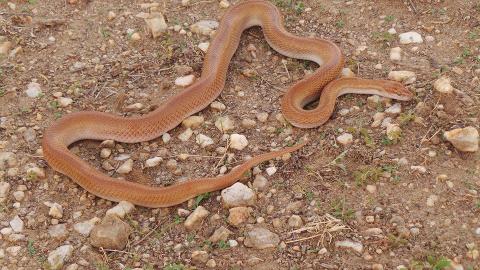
[285,214,350,245]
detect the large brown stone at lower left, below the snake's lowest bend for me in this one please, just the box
[90,215,132,250]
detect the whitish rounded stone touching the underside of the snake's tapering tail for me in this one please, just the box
[221,183,256,208]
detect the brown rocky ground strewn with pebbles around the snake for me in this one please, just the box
[0,0,480,270]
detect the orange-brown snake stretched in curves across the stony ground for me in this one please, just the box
[42,0,412,208]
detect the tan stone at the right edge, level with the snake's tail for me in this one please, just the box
[443,126,479,152]
